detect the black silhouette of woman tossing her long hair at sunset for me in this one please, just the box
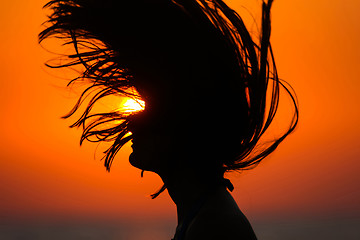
[39,0,298,240]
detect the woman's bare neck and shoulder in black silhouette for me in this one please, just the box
[162,164,256,240]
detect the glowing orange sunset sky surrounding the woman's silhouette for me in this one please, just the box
[0,0,360,224]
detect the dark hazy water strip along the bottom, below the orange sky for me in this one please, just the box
[0,218,360,240]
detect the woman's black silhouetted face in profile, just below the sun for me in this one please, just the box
[128,92,185,173]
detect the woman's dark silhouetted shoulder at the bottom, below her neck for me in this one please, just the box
[185,188,256,240]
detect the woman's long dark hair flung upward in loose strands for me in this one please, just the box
[39,0,298,181]
